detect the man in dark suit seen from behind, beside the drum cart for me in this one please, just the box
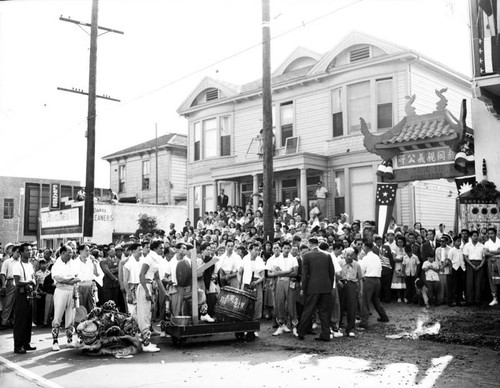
[298,237,335,342]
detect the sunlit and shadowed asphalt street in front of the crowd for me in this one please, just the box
[0,312,499,388]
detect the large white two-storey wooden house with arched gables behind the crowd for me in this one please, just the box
[178,32,471,226]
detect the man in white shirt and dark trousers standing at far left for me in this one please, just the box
[12,243,36,354]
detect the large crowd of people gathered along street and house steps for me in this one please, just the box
[0,198,500,353]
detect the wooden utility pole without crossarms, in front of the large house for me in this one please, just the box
[262,0,274,242]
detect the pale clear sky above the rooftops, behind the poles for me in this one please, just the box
[0,0,471,187]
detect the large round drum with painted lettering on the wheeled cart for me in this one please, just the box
[215,287,257,322]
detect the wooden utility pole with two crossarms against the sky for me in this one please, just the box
[57,0,123,238]
